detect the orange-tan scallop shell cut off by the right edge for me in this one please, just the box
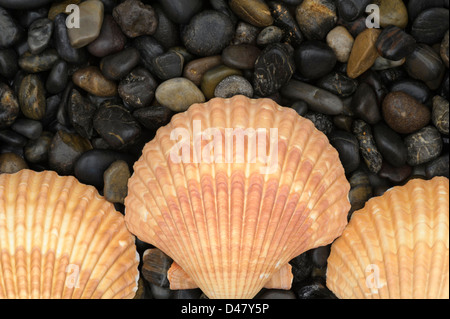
[327,177,449,299]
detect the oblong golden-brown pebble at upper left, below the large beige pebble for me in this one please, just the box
[72,66,117,97]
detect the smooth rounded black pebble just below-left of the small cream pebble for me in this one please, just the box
[294,40,337,80]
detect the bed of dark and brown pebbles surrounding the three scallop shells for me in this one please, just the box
[0,0,449,299]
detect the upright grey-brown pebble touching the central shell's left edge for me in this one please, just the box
[103,161,131,204]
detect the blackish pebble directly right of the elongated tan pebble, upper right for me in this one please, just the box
[376,25,416,61]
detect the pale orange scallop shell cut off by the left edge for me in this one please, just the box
[0,170,139,299]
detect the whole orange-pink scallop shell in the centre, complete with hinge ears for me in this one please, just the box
[125,96,350,298]
